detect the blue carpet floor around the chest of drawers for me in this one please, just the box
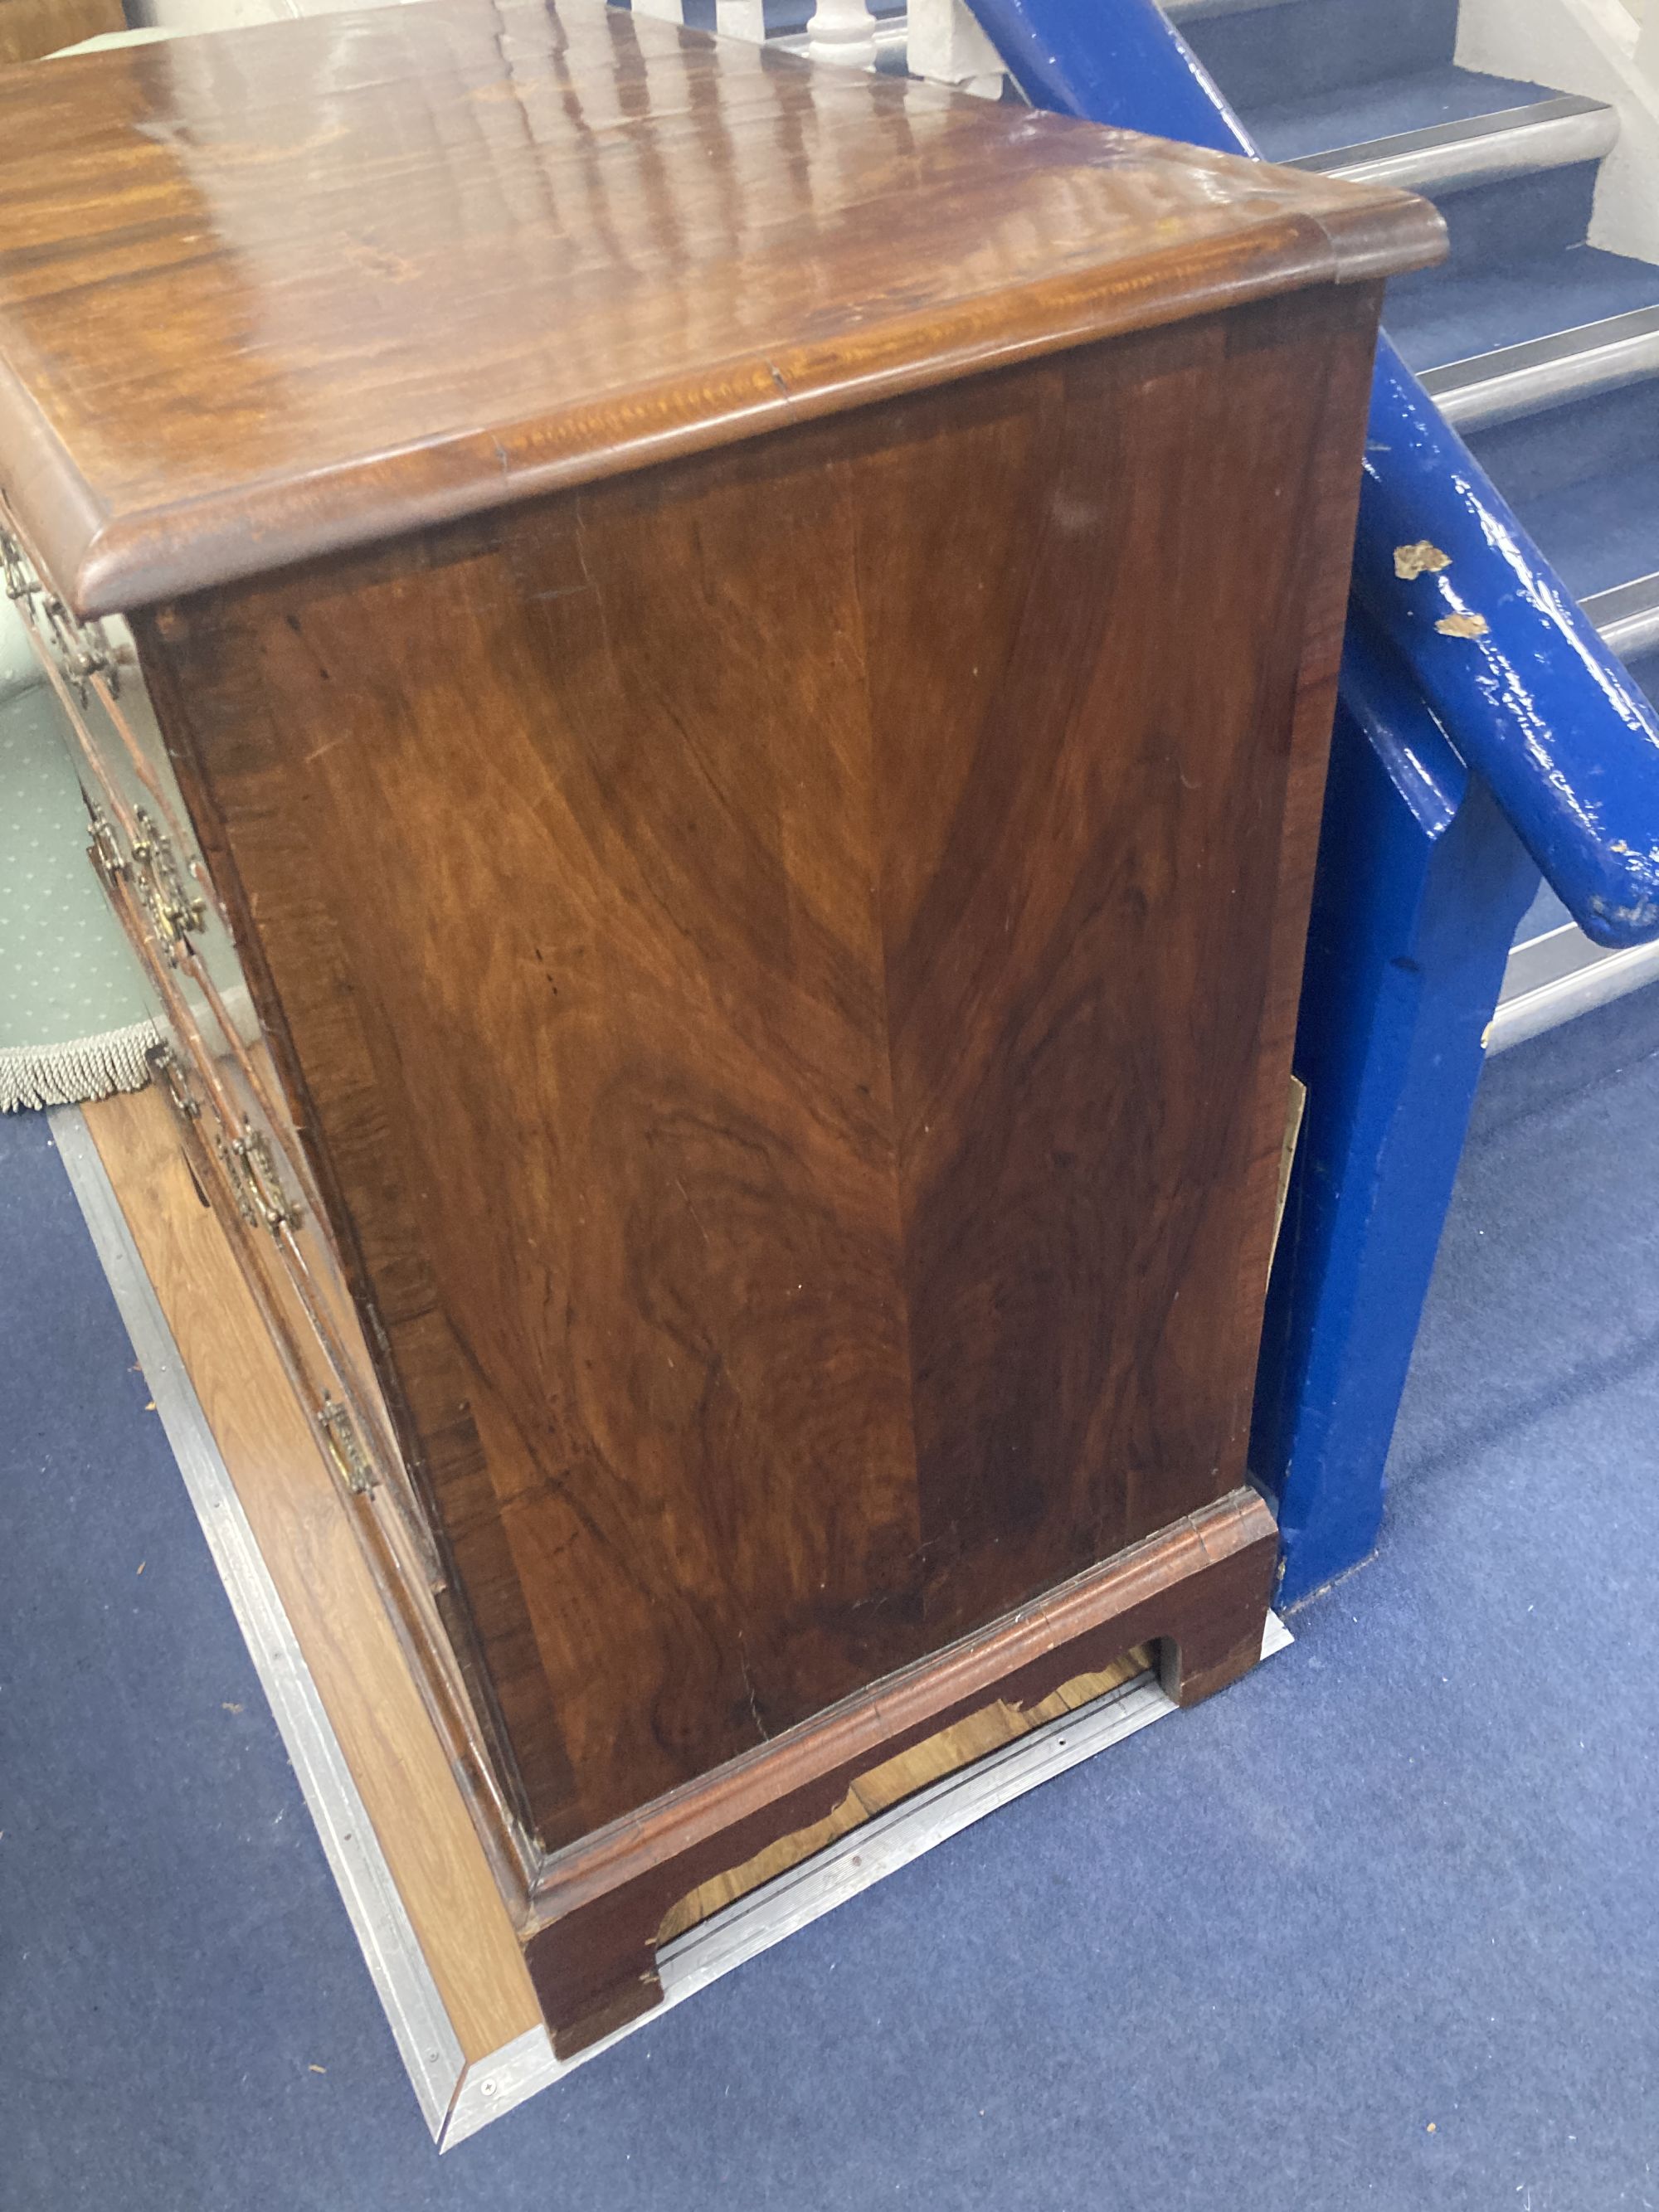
[0,993,1659,2212]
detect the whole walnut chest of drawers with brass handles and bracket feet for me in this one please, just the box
[0,0,1438,2050]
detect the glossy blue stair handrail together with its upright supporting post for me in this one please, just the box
[973,0,1659,1602]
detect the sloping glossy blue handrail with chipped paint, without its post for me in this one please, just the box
[973,0,1659,945]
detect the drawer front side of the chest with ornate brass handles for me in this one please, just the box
[0,518,528,1891]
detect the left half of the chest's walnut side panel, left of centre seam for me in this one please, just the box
[149,440,920,1843]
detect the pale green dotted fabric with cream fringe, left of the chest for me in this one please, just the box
[0,600,159,1111]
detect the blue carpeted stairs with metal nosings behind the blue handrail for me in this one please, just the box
[1165,0,1659,1046]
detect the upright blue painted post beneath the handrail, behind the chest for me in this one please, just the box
[1250,637,1537,1604]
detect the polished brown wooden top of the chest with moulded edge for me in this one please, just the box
[0,0,1440,615]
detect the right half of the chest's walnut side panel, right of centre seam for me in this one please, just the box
[860,289,1371,1637]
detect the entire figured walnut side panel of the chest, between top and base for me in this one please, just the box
[155,294,1365,1847]
